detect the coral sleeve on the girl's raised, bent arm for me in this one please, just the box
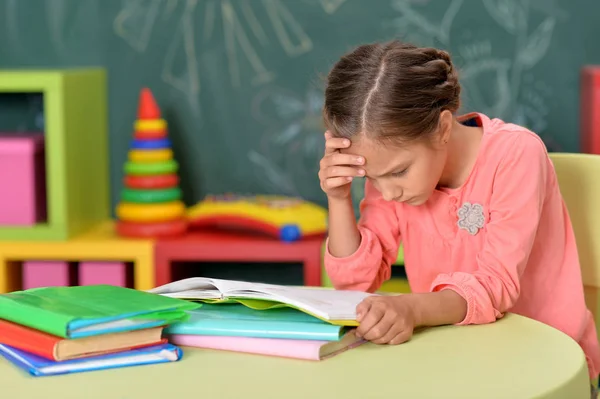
[324,180,400,292]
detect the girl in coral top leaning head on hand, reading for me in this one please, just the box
[319,41,600,394]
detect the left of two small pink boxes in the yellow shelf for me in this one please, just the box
[23,261,75,290]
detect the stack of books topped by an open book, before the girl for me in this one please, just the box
[150,277,373,361]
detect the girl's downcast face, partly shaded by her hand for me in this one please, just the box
[343,136,447,206]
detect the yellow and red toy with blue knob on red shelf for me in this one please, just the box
[187,194,327,242]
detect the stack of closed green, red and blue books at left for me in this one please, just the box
[0,285,199,376]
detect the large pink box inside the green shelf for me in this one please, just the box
[0,133,46,226]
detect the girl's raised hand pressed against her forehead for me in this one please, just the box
[319,132,365,199]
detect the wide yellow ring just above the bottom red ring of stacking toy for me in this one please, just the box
[117,201,185,222]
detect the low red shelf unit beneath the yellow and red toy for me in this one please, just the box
[154,230,324,286]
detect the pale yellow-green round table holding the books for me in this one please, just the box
[0,314,590,399]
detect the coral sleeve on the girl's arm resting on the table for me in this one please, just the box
[431,134,549,325]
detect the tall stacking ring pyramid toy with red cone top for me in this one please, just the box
[116,88,187,237]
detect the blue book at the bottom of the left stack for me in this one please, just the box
[0,344,183,377]
